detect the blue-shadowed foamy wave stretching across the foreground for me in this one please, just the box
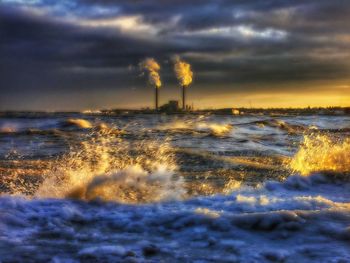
[0,175,350,262]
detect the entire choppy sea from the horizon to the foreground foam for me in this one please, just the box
[0,113,350,262]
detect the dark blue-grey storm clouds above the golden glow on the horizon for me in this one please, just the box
[0,0,350,109]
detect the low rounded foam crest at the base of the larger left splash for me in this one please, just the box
[66,165,185,203]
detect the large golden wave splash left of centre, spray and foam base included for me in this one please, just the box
[34,131,185,203]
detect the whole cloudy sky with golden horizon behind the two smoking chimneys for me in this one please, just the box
[0,0,350,110]
